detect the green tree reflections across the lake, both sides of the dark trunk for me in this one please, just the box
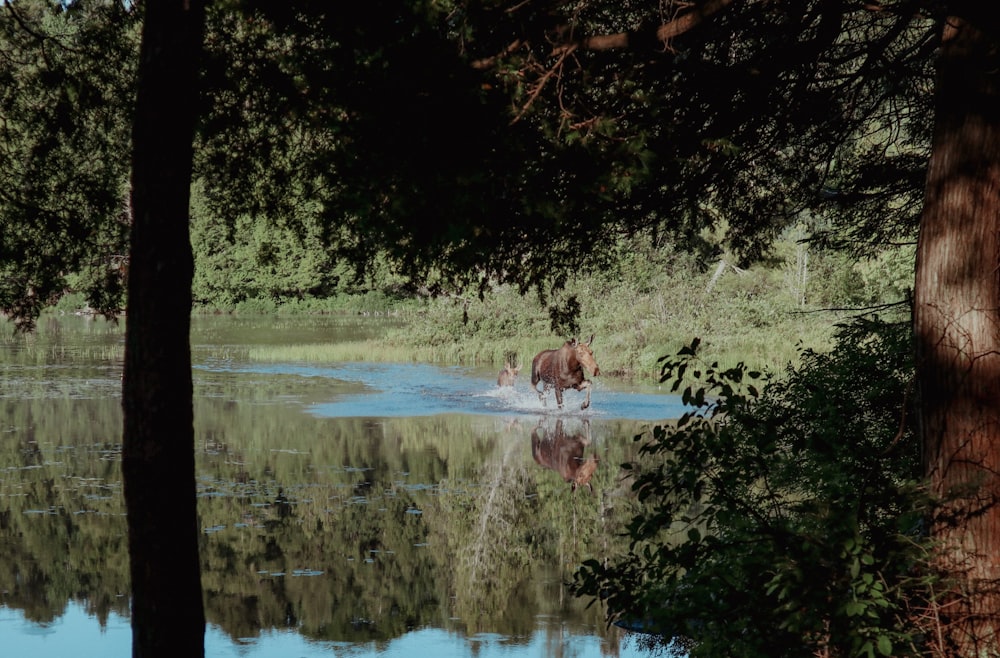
[0,388,648,642]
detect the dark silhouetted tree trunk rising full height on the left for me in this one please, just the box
[122,0,205,658]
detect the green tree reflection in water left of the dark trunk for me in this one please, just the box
[0,394,129,625]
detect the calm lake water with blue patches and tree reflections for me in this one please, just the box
[0,316,682,658]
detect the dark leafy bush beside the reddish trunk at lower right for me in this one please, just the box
[575,321,930,658]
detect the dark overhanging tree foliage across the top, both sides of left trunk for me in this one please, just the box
[0,0,934,321]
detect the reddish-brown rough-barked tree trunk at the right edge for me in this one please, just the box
[914,11,1000,657]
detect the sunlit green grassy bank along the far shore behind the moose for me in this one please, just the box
[41,234,912,383]
